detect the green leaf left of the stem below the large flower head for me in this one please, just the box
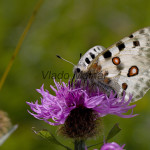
[32,127,71,150]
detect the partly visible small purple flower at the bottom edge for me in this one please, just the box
[100,142,125,150]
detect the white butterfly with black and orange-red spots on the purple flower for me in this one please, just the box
[73,27,150,102]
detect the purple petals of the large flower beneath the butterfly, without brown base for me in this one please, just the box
[27,80,136,125]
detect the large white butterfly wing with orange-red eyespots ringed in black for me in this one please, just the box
[96,27,150,101]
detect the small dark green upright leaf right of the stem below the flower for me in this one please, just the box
[106,123,121,143]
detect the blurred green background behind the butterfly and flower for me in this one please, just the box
[0,0,150,150]
